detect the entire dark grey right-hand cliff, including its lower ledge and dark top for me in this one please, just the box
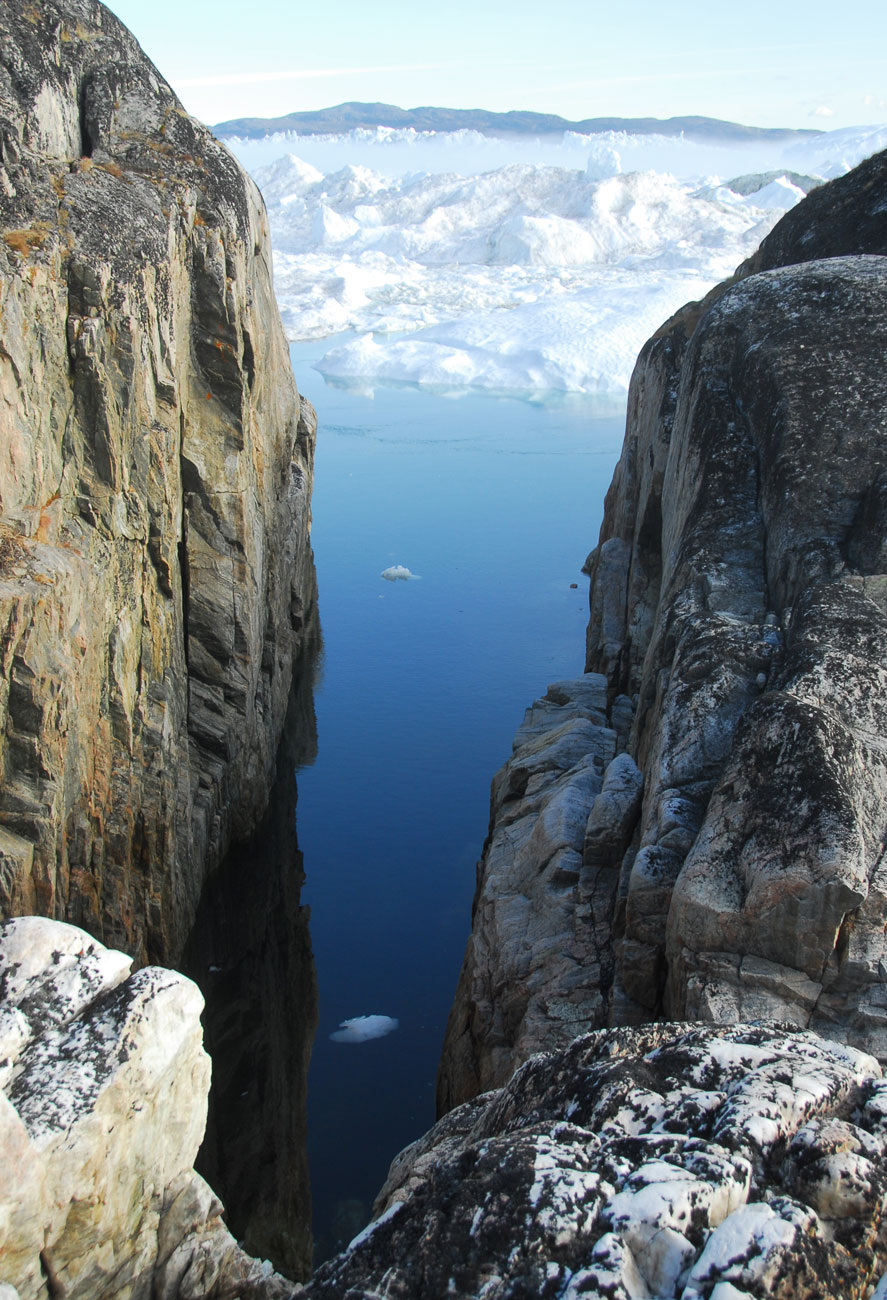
[438,155,887,1110]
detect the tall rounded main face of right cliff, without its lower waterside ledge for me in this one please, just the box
[589,215,887,1057]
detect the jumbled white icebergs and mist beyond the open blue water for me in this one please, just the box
[229,127,887,393]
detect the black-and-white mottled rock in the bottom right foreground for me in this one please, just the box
[306,1024,887,1300]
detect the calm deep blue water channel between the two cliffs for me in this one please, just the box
[293,342,624,1261]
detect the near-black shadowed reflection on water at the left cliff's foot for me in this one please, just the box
[183,624,321,1279]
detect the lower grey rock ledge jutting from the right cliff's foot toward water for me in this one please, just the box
[438,673,628,1110]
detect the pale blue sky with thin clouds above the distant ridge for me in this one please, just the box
[109,0,887,130]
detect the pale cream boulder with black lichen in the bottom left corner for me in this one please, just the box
[0,917,289,1300]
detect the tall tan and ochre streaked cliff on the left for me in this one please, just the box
[0,0,315,961]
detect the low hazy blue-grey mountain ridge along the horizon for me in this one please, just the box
[212,101,822,143]
